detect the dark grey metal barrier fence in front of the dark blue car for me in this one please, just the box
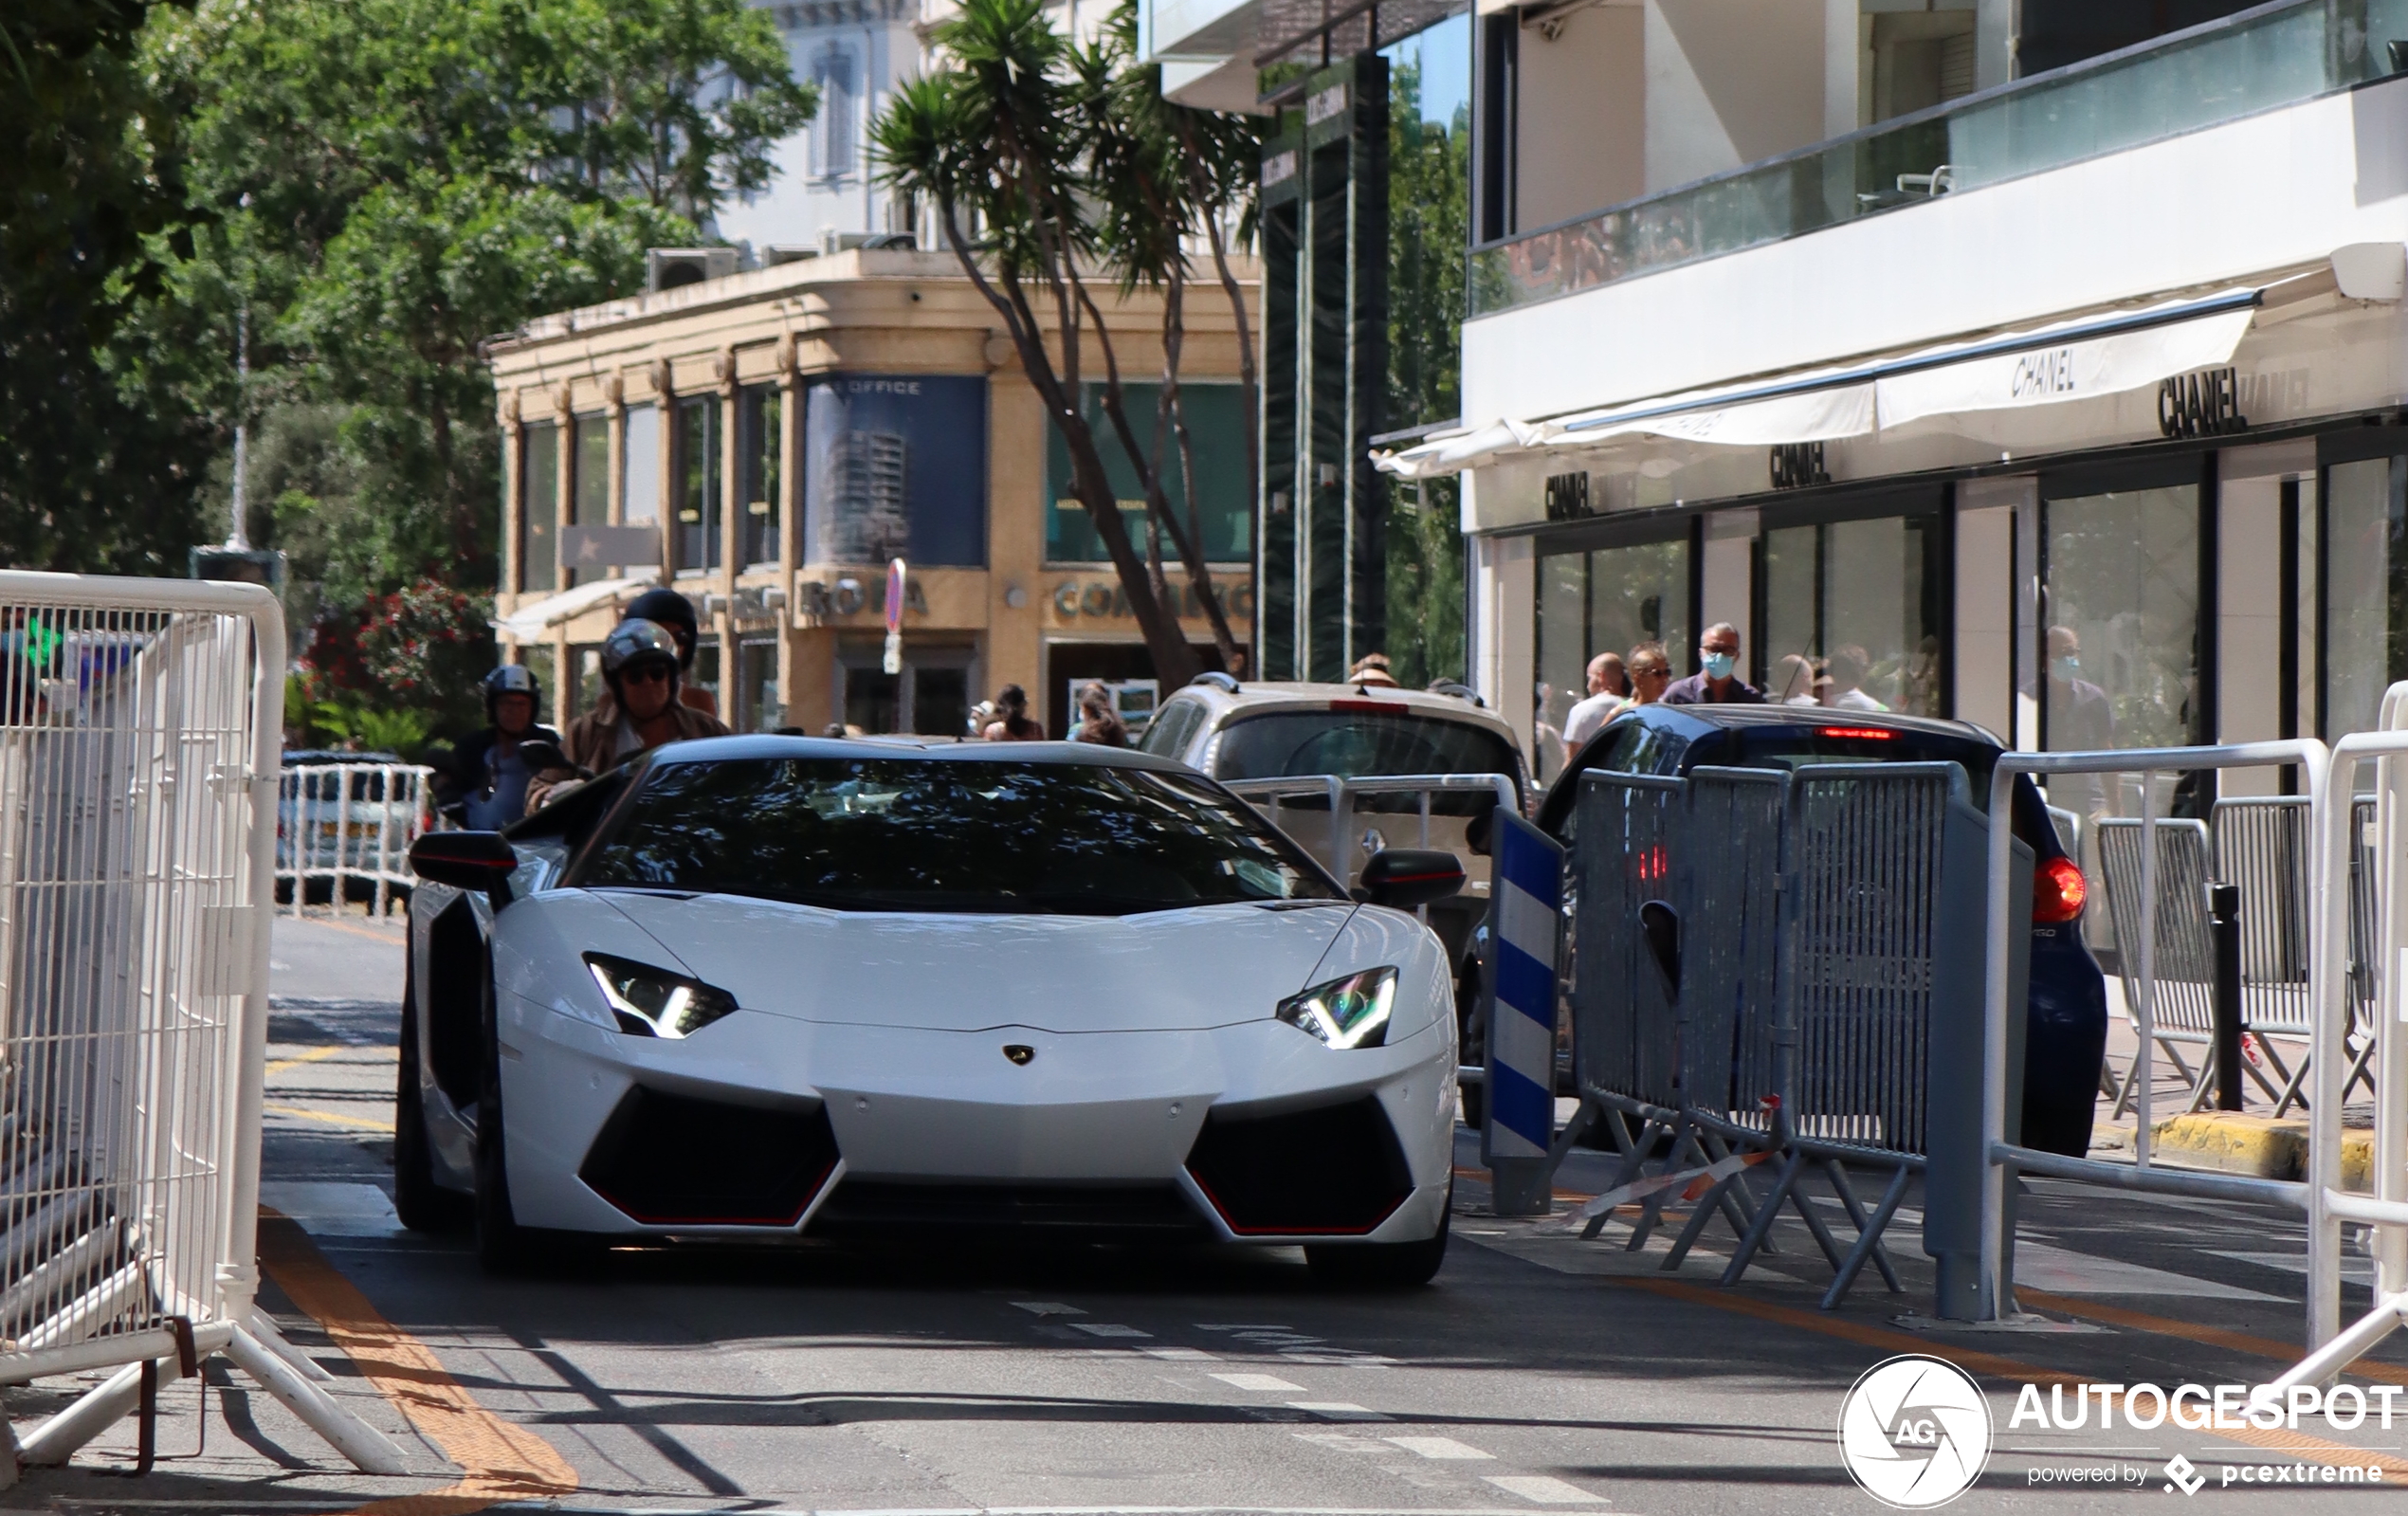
[1568,763,2030,1319]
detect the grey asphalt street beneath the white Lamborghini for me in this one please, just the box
[0,917,2408,1516]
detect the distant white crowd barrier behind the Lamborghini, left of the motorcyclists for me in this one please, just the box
[277,763,436,917]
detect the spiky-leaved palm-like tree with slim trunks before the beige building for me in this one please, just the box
[871,0,1252,684]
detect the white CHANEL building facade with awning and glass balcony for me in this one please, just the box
[1382,0,2408,811]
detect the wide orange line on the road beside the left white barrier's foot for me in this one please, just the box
[260,1208,578,1516]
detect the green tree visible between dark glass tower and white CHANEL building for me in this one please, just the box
[1387,63,1471,685]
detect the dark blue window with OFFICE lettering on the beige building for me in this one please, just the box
[802,373,987,570]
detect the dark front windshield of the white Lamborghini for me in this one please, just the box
[563,758,1343,914]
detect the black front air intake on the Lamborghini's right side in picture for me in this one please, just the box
[1187,1095,1414,1237]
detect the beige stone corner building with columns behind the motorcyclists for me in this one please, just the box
[491,247,1252,737]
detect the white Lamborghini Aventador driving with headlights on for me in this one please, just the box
[395,737,1462,1283]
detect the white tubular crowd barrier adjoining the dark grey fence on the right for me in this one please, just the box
[1974,736,2330,1342]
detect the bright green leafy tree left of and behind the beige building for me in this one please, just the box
[137,0,816,736]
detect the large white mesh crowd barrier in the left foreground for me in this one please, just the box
[0,573,402,1470]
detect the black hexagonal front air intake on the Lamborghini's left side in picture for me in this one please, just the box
[578,1087,835,1227]
